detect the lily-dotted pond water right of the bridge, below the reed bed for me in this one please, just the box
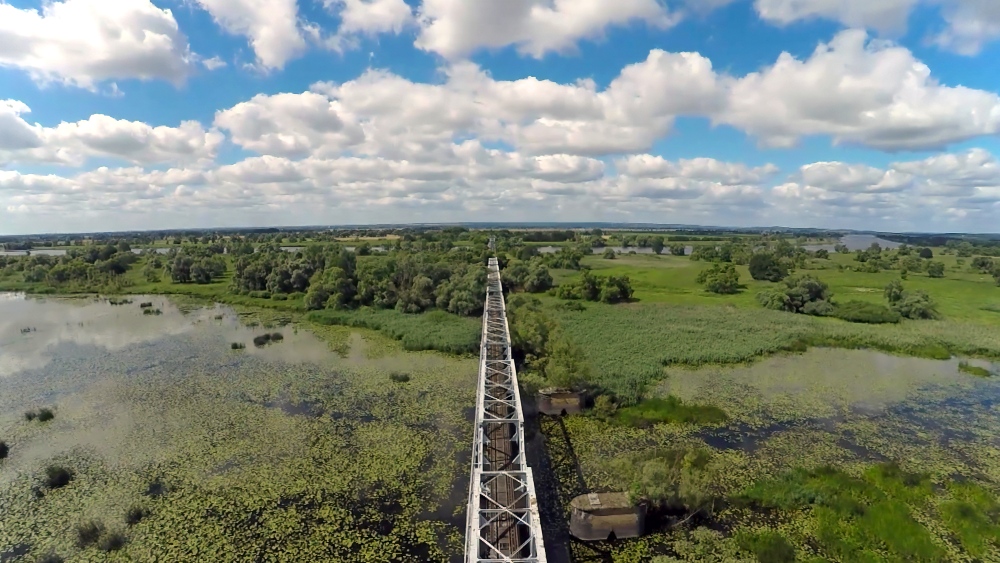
[657,348,1000,476]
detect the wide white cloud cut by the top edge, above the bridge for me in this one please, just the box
[416,0,677,59]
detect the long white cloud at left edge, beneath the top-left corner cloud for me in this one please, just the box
[0,100,223,166]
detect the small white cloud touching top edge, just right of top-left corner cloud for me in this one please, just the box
[196,0,306,70]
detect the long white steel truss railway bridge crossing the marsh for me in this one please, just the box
[465,254,546,563]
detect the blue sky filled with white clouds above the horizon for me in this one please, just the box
[0,0,1000,234]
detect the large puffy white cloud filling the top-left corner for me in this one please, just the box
[0,0,192,90]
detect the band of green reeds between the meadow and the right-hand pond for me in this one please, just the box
[552,303,1000,403]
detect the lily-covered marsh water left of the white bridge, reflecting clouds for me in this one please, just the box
[0,294,476,563]
